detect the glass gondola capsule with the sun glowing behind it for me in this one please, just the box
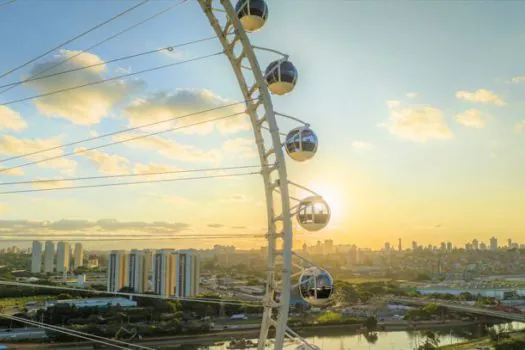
[296,196,331,231]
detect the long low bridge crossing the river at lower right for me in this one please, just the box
[388,297,525,322]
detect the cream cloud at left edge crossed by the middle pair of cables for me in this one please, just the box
[0,135,77,174]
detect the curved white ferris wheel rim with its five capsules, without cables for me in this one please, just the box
[199,0,333,350]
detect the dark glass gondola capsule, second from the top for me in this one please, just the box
[265,60,299,96]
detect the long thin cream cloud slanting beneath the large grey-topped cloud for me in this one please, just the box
[113,134,221,163]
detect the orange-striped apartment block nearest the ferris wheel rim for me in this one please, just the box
[153,250,200,297]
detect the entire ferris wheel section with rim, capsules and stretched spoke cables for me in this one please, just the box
[0,0,334,350]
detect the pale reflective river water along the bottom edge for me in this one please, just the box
[201,322,525,350]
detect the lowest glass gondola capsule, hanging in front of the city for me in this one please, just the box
[299,267,334,306]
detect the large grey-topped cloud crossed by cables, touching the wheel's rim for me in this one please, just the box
[124,89,250,134]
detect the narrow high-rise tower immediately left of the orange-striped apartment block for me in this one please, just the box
[126,249,153,293]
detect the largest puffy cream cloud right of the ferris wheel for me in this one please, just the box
[382,106,453,142]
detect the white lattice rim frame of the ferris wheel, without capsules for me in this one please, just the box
[198,0,318,350]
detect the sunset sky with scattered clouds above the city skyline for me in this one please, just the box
[0,0,525,249]
